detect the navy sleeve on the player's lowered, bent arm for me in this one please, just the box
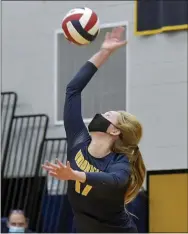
[86,160,130,188]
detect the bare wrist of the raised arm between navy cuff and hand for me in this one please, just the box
[89,49,111,68]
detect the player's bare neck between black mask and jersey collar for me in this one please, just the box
[88,135,113,158]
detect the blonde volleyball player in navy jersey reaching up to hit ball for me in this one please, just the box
[43,27,146,233]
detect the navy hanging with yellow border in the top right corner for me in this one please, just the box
[135,0,188,35]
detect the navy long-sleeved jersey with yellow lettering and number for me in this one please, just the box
[64,62,136,233]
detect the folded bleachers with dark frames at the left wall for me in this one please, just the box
[1,92,70,232]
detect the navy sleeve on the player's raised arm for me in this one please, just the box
[64,61,97,150]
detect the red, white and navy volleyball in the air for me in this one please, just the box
[62,7,100,45]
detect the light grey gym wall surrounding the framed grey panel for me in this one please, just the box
[2,1,187,170]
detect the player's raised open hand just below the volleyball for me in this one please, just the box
[101,27,127,52]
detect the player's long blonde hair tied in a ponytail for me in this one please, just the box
[113,111,146,204]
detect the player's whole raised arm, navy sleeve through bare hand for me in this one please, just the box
[64,27,127,153]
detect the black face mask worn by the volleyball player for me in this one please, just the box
[88,114,111,133]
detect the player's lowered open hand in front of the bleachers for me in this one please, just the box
[42,159,75,180]
